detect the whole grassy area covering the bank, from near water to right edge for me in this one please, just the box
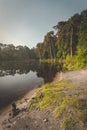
[28,80,87,130]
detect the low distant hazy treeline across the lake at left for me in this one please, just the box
[0,43,36,61]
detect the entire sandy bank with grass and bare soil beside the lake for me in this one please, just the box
[0,69,87,130]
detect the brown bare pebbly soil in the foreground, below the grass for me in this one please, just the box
[3,111,59,130]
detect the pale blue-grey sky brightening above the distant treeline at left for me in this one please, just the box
[0,0,87,48]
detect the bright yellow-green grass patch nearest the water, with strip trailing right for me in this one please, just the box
[28,80,75,109]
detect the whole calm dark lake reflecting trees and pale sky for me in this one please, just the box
[0,62,60,110]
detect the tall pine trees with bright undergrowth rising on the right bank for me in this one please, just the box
[36,10,87,69]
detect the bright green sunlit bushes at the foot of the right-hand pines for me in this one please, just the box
[63,47,87,70]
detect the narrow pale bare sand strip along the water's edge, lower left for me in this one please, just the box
[0,89,36,130]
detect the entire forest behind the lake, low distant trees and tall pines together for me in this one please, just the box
[0,10,87,70]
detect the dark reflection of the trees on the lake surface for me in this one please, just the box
[0,62,61,82]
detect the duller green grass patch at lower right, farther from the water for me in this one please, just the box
[54,96,85,117]
